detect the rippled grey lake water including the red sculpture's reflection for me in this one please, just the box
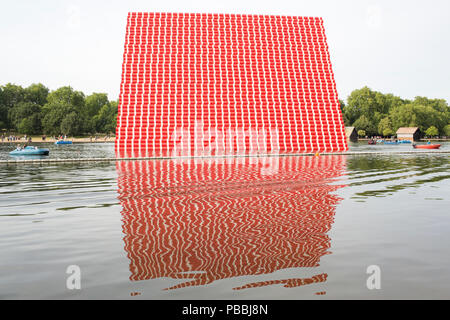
[0,143,450,299]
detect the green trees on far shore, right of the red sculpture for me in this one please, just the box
[340,87,450,137]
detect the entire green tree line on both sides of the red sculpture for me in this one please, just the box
[0,83,450,137]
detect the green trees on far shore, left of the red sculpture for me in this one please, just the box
[0,83,118,136]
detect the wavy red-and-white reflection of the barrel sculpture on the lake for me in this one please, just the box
[117,156,345,289]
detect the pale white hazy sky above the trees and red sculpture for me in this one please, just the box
[0,0,450,102]
